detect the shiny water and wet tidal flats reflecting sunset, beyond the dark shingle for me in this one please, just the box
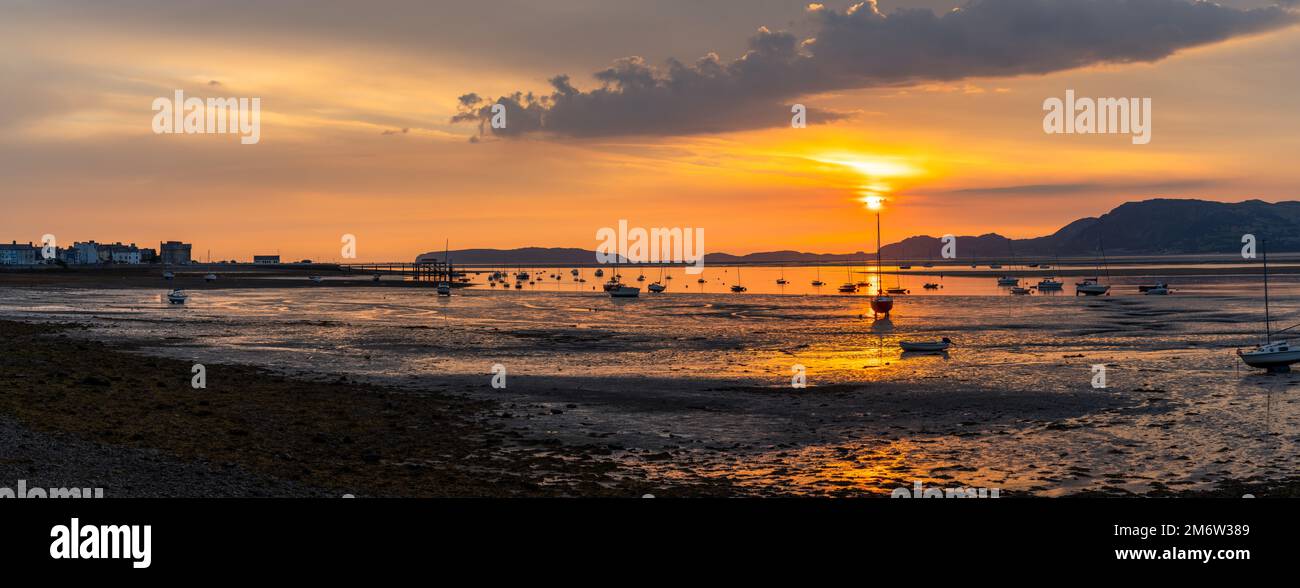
[0,267,1300,494]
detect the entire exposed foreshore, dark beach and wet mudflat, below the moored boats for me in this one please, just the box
[0,279,1300,497]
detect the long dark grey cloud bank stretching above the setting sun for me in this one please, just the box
[452,0,1296,137]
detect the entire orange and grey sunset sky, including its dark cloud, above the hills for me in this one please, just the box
[0,0,1300,260]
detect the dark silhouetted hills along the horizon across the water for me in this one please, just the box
[417,198,1300,265]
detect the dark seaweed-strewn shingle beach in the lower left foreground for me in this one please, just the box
[0,321,728,497]
